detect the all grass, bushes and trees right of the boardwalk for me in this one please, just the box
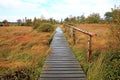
[63,7,120,80]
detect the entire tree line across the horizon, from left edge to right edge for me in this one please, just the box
[0,6,120,26]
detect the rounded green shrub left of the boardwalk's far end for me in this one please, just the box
[38,23,54,32]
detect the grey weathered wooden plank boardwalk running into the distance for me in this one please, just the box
[39,27,86,80]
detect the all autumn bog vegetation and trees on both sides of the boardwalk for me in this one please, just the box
[0,7,120,80]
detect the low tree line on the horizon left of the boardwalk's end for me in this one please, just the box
[0,17,58,26]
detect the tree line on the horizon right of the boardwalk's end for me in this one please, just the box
[64,7,120,24]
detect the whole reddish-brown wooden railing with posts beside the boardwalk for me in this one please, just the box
[64,24,96,62]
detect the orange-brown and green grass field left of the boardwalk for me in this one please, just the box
[0,27,52,80]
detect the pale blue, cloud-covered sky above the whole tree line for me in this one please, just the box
[0,0,120,22]
